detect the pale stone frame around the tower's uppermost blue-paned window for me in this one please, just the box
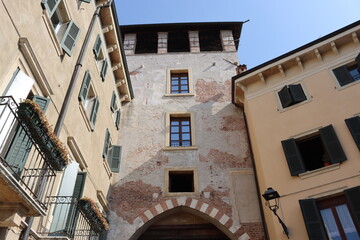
[165,68,195,97]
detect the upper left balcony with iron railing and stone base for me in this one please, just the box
[0,96,56,227]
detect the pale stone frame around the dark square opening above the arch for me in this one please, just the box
[163,167,200,197]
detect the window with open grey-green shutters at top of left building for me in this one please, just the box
[41,0,80,56]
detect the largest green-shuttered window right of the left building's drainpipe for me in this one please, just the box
[78,71,99,130]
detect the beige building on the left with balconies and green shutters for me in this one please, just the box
[0,0,133,240]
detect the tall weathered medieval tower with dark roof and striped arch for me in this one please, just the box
[108,22,263,240]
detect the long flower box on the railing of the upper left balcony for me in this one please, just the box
[18,99,70,171]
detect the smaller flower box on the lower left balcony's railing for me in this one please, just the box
[79,197,110,232]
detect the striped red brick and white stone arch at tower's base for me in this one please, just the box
[130,197,250,240]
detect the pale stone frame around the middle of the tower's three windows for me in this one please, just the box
[163,112,198,151]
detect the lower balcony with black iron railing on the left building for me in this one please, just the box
[37,196,101,240]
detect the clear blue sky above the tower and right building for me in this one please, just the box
[115,0,360,69]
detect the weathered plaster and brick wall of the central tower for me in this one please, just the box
[109,52,262,239]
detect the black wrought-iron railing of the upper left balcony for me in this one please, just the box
[0,96,56,214]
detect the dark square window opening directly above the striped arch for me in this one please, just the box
[169,170,194,193]
